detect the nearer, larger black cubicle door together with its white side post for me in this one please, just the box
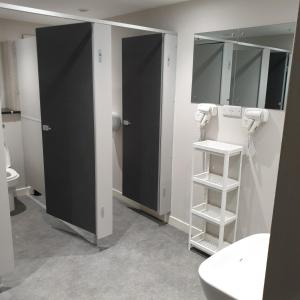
[37,23,112,242]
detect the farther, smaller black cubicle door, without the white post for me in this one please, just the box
[122,34,163,210]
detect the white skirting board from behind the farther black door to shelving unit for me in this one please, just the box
[113,189,189,233]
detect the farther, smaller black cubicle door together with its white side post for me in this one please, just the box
[122,33,176,216]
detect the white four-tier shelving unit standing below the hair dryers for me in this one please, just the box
[189,140,243,255]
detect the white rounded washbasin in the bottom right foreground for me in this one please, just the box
[199,233,270,300]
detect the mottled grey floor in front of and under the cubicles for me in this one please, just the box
[0,197,205,300]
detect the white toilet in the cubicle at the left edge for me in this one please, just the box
[4,145,20,211]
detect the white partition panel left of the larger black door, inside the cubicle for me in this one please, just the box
[16,37,45,193]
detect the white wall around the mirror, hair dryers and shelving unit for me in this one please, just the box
[115,0,298,237]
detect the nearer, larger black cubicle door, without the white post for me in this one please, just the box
[36,23,96,233]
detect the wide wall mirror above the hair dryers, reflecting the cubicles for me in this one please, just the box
[191,23,296,110]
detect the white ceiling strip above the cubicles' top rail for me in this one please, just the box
[3,0,188,19]
